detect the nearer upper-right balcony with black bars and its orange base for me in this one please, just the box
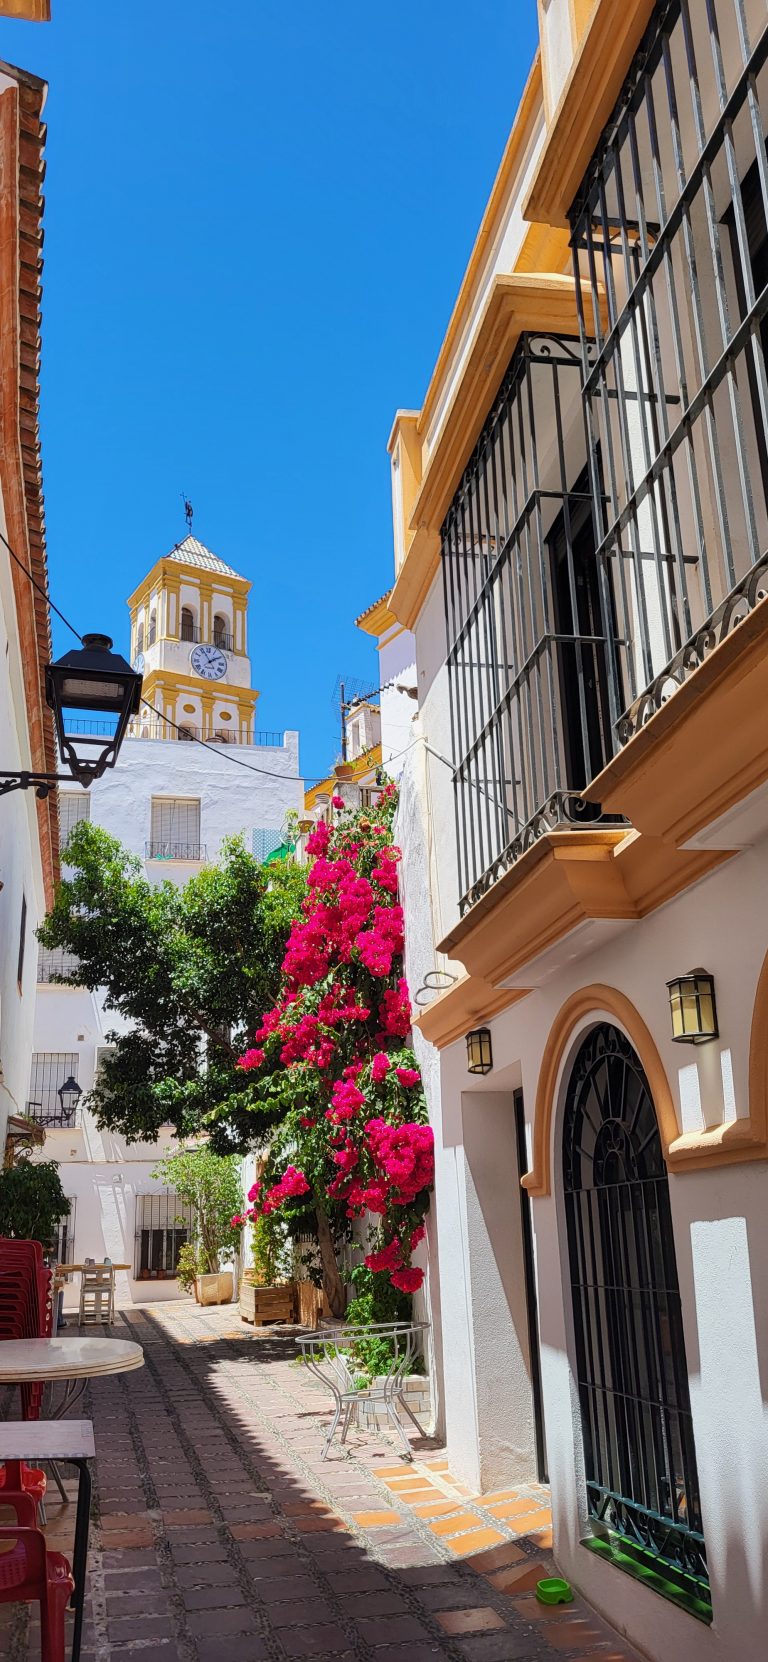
[572,0,768,851]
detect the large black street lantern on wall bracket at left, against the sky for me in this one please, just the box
[0,635,141,796]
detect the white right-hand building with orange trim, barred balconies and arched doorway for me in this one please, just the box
[389,0,768,1662]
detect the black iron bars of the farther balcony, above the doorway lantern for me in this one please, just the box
[441,334,610,911]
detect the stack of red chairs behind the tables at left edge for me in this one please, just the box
[0,1240,53,1514]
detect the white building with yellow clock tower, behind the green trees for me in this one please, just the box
[27,538,304,1303]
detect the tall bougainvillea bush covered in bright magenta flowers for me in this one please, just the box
[224,784,434,1315]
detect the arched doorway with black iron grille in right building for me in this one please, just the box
[564,1022,710,1605]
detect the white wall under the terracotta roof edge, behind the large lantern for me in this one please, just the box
[0,485,45,1150]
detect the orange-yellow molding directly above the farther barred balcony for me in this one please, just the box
[389,271,601,628]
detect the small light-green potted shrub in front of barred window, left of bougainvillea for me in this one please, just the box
[153,1145,243,1305]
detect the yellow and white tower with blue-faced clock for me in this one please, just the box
[128,534,259,745]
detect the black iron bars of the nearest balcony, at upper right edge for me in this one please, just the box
[570,0,768,745]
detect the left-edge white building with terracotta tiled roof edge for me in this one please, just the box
[0,65,58,1155]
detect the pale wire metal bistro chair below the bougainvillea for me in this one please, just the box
[299,1321,429,1459]
